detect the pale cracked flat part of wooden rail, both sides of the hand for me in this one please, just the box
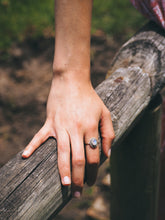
[0,68,150,219]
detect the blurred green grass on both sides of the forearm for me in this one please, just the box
[0,0,144,50]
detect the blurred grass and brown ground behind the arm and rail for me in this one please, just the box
[0,0,151,220]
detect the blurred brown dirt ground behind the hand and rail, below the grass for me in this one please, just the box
[0,32,165,220]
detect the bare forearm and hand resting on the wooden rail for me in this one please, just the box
[22,0,114,197]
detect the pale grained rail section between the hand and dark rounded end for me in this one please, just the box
[96,67,151,144]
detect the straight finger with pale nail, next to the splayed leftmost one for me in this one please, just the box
[57,131,71,186]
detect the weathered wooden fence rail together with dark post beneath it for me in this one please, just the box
[0,22,165,220]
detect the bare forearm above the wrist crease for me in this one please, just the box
[53,0,92,80]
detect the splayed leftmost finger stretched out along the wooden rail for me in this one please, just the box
[22,124,53,158]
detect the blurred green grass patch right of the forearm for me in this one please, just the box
[92,0,145,38]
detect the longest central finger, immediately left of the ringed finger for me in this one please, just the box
[71,134,85,198]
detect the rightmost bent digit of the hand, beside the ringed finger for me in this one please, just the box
[100,108,115,157]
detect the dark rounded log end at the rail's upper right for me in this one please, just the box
[107,22,165,96]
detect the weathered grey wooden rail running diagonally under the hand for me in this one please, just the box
[0,22,165,220]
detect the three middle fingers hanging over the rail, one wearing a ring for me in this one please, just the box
[57,125,100,194]
